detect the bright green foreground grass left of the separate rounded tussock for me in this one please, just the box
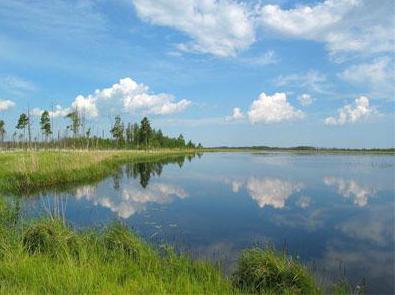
[0,215,236,294]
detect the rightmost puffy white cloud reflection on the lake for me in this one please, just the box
[324,176,376,207]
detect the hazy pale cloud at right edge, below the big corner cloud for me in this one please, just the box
[339,57,395,99]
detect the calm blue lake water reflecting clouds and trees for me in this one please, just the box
[23,153,395,293]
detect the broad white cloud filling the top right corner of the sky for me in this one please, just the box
[258,0,395,54]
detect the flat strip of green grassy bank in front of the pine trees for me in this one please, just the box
[0,150,195,195]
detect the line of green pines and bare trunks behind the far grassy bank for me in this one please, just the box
[0,109,202,149]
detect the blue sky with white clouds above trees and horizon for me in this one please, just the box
[0,0,395,148]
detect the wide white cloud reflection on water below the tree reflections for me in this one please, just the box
[74,183,188,219]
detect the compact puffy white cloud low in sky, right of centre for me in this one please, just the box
[248,92,304,124]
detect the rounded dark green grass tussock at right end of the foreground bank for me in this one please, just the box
[233,248,320,294]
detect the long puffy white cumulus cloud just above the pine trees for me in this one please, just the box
[35,78,191,118]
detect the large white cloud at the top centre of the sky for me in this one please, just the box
[133,0,255,57]
